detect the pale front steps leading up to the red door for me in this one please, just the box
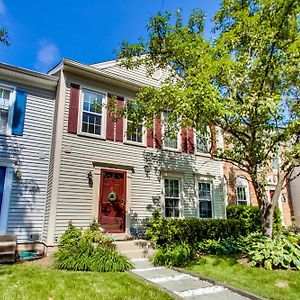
[113,240,155,259]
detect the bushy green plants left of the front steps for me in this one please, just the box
[54,223,132,272]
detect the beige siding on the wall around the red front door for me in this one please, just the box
[55,81,224,239]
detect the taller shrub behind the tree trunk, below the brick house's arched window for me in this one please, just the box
[226,205,281,236]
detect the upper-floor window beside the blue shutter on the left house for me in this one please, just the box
[0,86,13,134]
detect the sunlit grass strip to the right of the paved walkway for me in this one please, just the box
[186,255,300,300]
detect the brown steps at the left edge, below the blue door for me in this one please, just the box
[0,235,17,264]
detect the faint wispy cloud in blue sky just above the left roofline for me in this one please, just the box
[34,40,60,72]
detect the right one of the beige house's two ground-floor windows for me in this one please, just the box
[198,182,212,218]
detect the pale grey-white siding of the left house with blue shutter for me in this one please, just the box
[0,83,55,242]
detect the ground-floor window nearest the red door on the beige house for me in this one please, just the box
[165,179,180,218]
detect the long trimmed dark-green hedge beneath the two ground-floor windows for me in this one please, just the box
[145,216,241,246]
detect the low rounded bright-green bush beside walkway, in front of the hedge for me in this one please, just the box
[152,243,194,267]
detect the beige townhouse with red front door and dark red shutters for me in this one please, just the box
[44,59,225,246]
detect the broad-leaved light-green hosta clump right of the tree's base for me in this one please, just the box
[249,235,300,270]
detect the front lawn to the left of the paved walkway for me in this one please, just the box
[0,263,172,300]
